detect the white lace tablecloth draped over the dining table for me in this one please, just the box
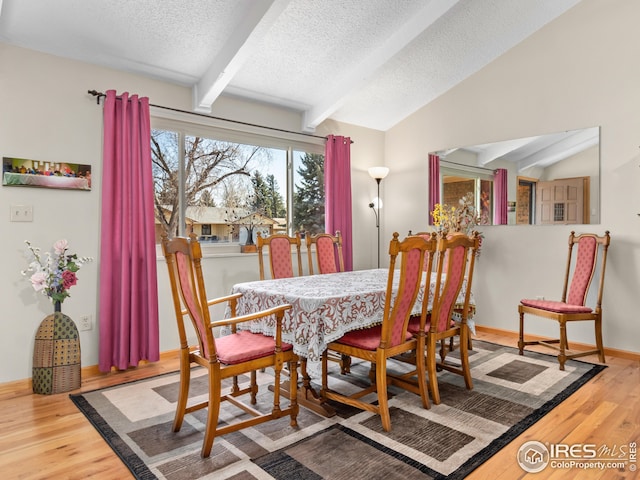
[226,269,475,377]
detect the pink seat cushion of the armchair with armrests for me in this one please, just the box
[215,330,293,365]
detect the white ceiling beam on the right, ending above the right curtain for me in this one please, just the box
[302,0,459,132]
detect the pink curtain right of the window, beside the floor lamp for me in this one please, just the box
[324,135,353,272]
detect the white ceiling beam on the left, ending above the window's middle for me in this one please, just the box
[193,0,291,113]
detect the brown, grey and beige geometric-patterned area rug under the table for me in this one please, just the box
[71,340,605,480]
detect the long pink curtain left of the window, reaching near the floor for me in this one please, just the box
[99,90,160,372]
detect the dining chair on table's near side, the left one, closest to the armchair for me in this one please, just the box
[320,232,435,431]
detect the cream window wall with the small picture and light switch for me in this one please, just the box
[0,43,384,382]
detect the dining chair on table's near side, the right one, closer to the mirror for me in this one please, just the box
[394,231,480,405]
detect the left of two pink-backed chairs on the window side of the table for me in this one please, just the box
[256,232,302,280]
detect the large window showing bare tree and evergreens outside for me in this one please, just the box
[151,114,324,244]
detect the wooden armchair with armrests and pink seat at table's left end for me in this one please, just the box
[162,234,298,458]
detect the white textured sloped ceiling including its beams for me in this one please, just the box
[0,0,580,132]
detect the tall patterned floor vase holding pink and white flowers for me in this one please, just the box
[22,240,92,394]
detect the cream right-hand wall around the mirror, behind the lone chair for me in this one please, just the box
[384,0,640,352]
